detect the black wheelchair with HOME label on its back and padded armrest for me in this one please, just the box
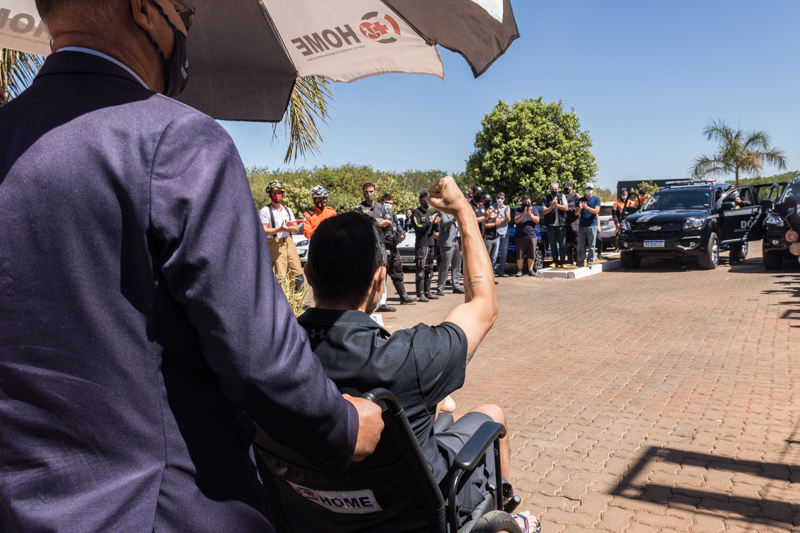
[253,389,523,533]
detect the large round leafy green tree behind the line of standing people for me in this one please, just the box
[467,95,597,202]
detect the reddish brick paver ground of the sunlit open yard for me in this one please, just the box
[384,243,800,533]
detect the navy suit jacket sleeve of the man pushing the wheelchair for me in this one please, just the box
[150,112,358,475]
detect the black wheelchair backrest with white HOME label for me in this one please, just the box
[253,390,446,533]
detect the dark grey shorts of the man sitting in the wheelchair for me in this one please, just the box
[436,413,496,525]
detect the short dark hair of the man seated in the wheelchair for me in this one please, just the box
[308,212,386,308]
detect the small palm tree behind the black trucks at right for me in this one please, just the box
[690,120,786,187]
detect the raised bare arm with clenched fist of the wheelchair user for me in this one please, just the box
[428,176,500,356]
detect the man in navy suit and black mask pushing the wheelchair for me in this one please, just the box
[0,0,382,533]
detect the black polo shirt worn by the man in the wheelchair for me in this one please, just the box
[298,308,467,481]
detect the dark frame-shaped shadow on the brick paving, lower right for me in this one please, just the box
[611,439,800,530]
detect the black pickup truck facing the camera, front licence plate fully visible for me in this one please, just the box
[618,180,777,270]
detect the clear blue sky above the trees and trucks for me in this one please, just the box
[223,0,800,187]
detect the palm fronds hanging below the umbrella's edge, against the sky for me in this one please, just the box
[273,76,333,163]
